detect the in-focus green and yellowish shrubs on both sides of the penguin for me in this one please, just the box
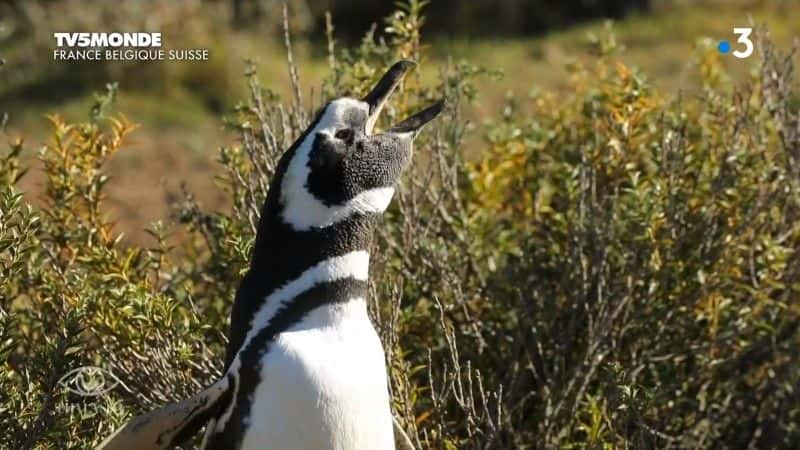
[0,2,800,449]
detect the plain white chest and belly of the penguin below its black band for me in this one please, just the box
[241,299,394,450]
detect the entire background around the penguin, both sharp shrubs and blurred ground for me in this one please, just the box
[0,0,800,449]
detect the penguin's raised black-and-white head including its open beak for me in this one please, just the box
[276,61,444,230]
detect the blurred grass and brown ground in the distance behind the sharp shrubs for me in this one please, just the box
[0,0,800,242]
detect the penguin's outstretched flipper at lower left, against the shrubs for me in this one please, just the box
[95,378,227,450]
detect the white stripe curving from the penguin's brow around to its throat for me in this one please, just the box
[281,98,394,231]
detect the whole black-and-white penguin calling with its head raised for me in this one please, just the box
[95,61,444,450]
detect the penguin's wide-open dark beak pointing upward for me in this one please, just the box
[364,60,444,134]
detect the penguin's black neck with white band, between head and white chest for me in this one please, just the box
[225,206,377,369]
